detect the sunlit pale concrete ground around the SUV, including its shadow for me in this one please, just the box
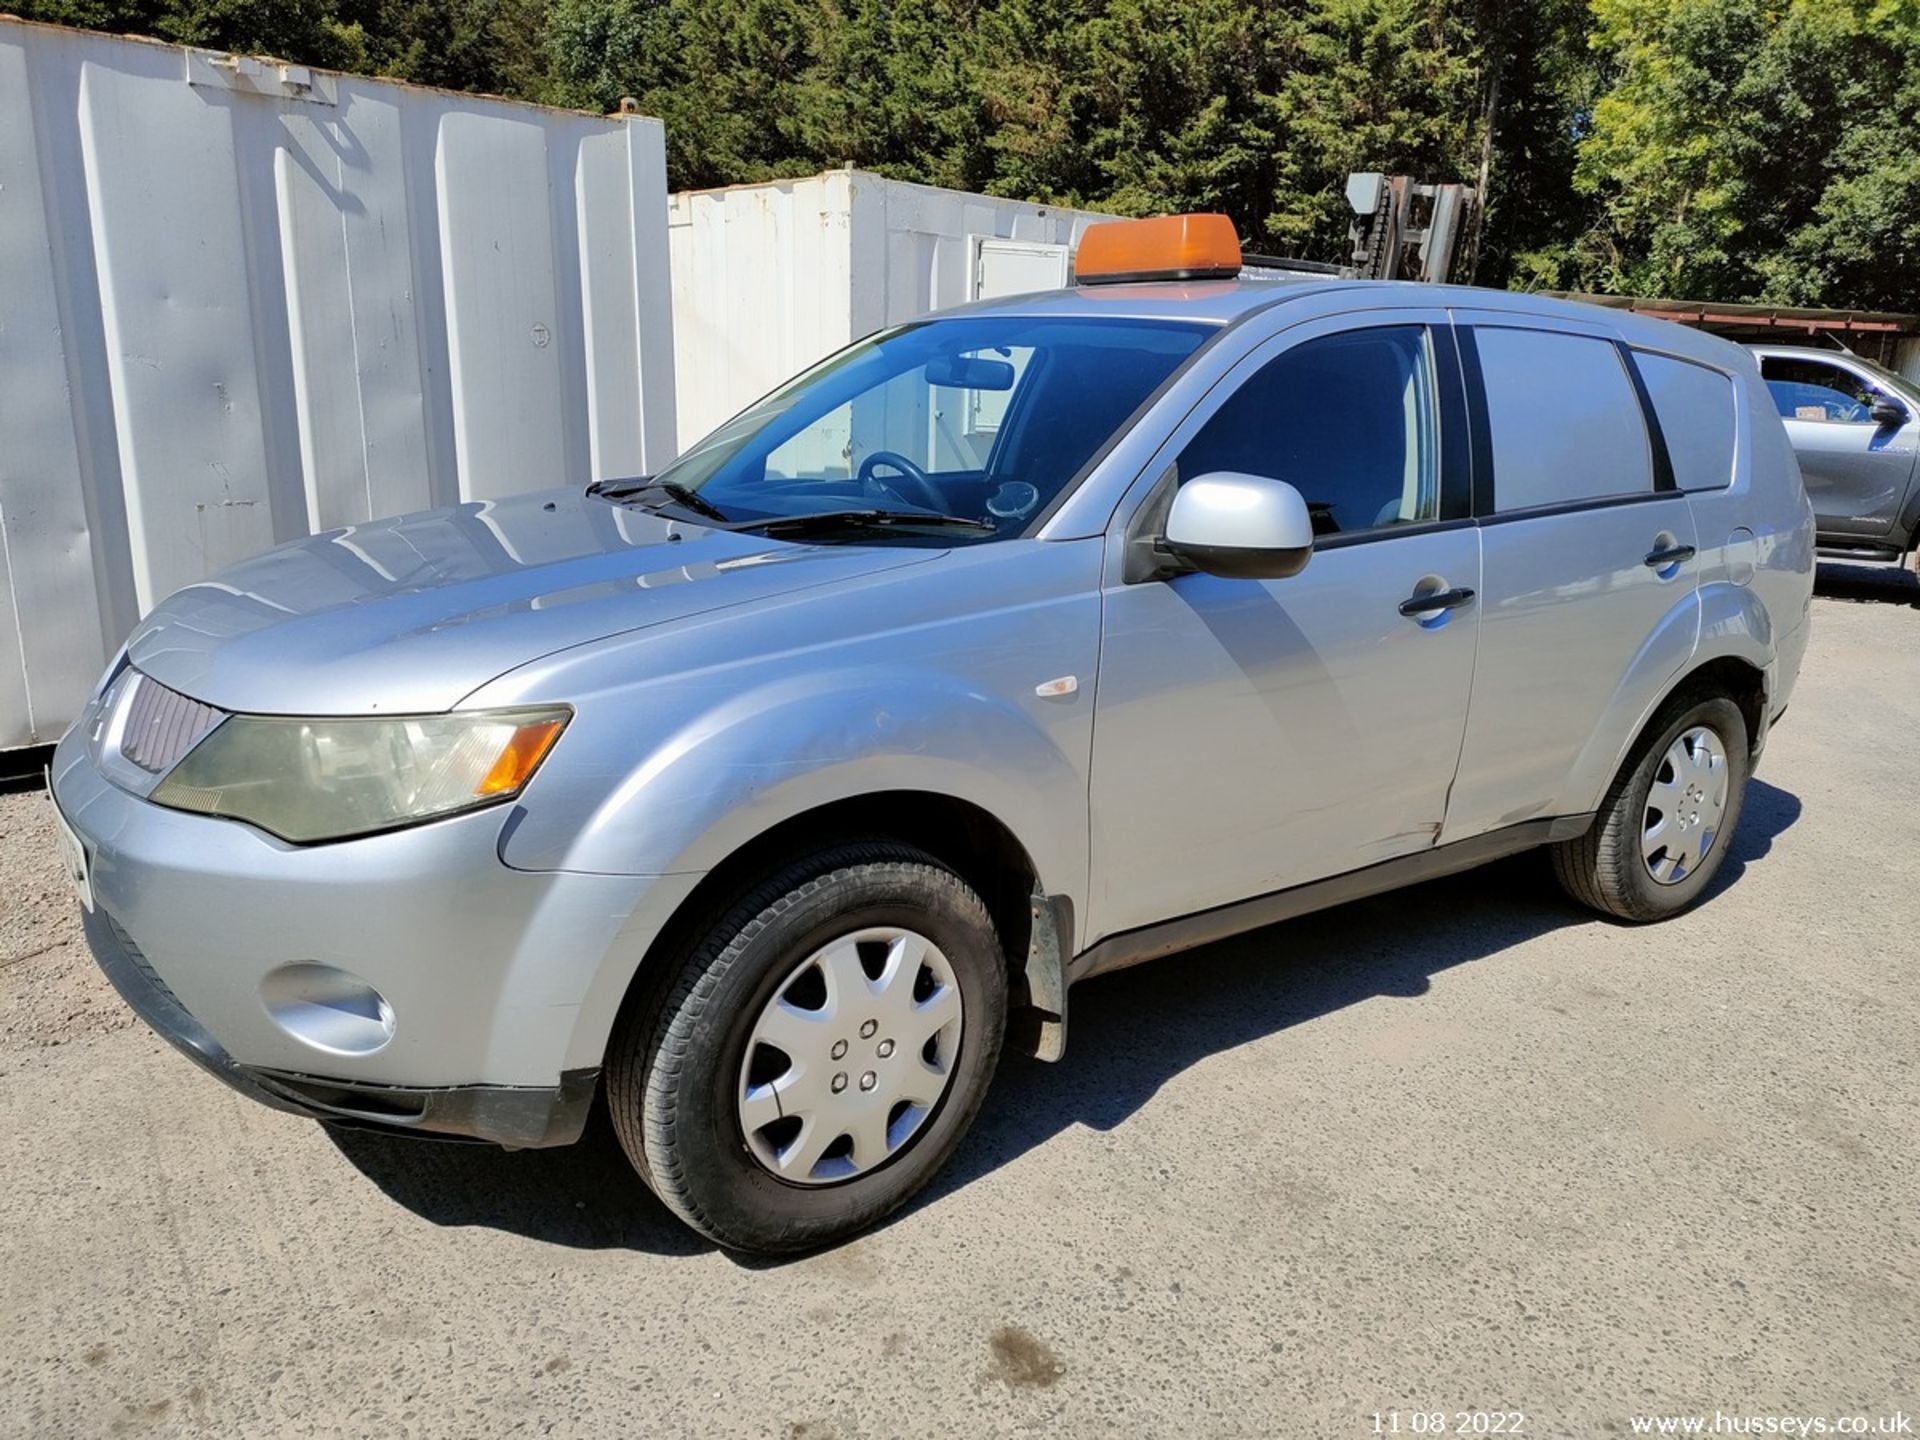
[0,566,1920,1436]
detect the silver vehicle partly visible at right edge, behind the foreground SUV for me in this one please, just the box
[1753,346,1920,559]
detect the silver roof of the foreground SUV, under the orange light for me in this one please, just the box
[933,271,1755,372]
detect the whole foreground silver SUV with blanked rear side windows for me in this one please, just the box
[52,227,1814,1252]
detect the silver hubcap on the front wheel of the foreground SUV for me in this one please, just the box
[737,925,962,1185]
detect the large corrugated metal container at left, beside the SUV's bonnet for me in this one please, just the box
[0,19,674,747]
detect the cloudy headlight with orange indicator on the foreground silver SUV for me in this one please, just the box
[150,708,570,843]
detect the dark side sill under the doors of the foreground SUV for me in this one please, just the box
[1068,812,1594,983]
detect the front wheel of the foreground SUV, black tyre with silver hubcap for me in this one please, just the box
[607,841,1006,1254]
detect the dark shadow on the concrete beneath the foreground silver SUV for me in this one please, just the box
[328,780,1801,1263]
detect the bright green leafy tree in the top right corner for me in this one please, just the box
[1572,0,1920,309]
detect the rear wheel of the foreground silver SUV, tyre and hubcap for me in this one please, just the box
[1551,693,1749,922]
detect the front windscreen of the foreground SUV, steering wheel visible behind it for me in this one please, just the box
[657,315,1212,543]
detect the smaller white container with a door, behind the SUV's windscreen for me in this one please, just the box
[668,169,1114,465]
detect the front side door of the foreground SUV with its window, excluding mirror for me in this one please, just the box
[1087,311,1480,943]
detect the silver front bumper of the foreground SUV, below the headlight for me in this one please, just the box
[52,728,697,1146]
